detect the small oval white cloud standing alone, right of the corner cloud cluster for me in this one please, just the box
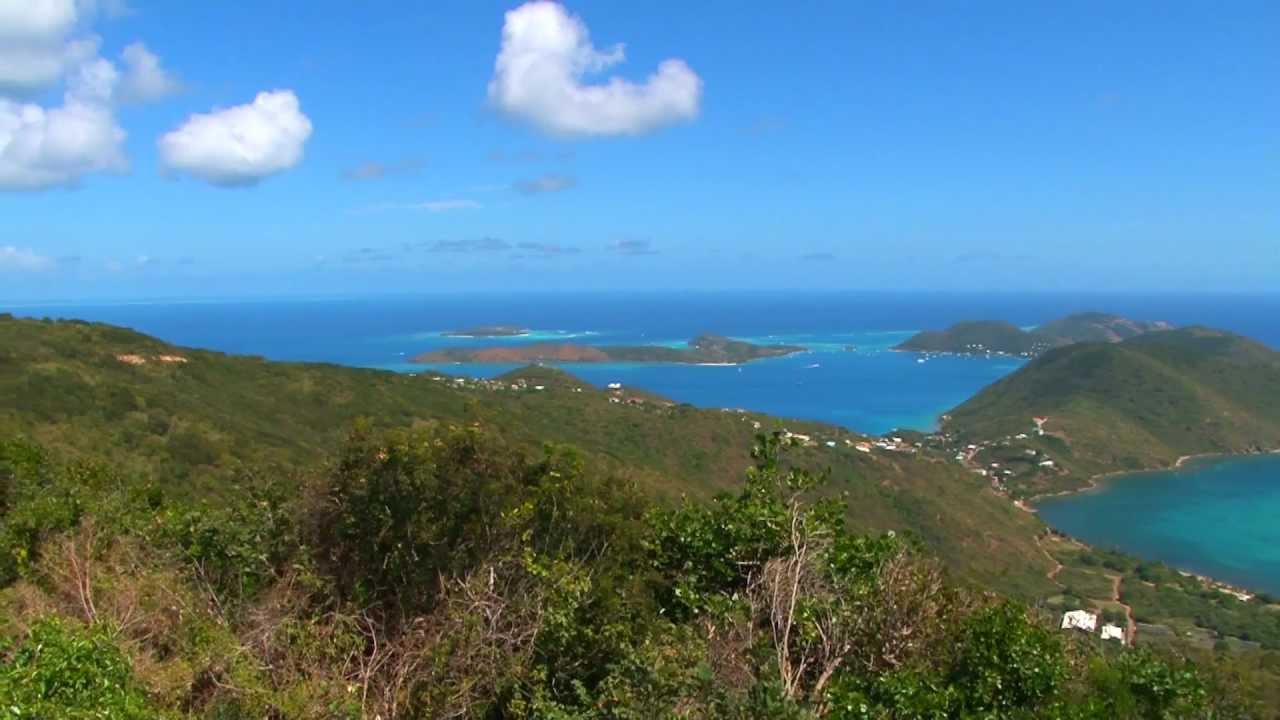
[159,90,311,186]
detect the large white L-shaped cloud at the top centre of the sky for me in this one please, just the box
[489,0,703,136]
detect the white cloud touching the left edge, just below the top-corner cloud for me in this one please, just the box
[0,59,128,190]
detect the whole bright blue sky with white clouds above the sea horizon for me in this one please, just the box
[0,0,1280,301]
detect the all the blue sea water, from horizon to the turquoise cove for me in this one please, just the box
[0,292,1280,589]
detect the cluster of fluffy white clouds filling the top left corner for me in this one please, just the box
[0,0,177,191]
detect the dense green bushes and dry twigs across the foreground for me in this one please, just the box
[0,424,1267,720]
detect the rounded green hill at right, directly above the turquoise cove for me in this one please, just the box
[946,328,1280,489]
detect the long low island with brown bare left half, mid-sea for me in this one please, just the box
[413,334,805,365]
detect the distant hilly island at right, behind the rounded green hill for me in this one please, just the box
[893,313,1172,357]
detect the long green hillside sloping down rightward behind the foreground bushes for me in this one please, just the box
[0,318,1046,597]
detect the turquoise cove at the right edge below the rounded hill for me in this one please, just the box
[1037,455,1280,594]
